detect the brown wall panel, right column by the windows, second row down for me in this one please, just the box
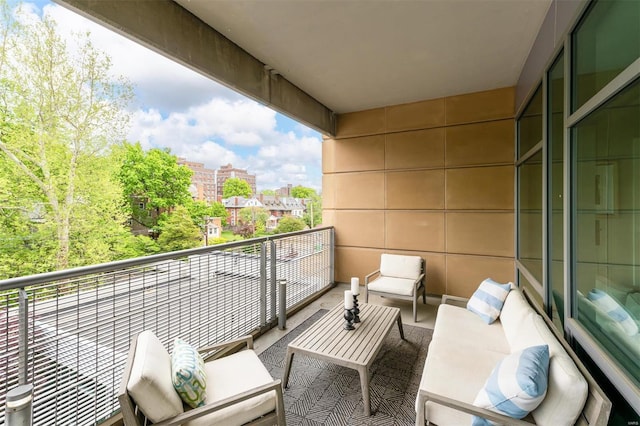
[445,119,515,167]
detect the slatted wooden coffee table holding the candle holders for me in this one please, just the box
[282,304,404,416]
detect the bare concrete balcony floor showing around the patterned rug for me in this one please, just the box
[254,283,441,354]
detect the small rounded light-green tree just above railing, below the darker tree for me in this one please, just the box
[158,206,202,252]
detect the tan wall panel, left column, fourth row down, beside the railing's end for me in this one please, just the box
[335,210,384,247]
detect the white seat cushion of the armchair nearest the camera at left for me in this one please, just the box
[185,350,276,426]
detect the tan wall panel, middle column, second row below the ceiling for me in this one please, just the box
[385,128,445,170]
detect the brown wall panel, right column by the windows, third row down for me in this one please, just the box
[445,166,514,210]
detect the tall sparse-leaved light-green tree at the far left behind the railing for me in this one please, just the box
[0,5,133,275]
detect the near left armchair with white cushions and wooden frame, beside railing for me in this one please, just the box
[118,331,286,426]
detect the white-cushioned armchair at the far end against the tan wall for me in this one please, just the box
[364,253,427,322]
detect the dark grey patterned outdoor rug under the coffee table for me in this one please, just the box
[260,309,433,426]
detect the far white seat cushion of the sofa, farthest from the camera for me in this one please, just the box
[433,304,511,356]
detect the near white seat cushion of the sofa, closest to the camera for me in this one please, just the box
[420,338,506,426]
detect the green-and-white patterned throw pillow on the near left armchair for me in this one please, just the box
[171,338,207,408]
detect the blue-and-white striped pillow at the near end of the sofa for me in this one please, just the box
[472,345,549,426]
